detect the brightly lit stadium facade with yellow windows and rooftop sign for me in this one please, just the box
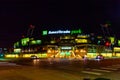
[6,29,120,58]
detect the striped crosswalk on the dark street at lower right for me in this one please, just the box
[81,64,120,76]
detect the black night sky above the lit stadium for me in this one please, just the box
[0,0,120,47]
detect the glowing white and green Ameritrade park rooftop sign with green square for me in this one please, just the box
[42,29,82,35]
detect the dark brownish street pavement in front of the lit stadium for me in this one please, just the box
[0,59,120,80]
